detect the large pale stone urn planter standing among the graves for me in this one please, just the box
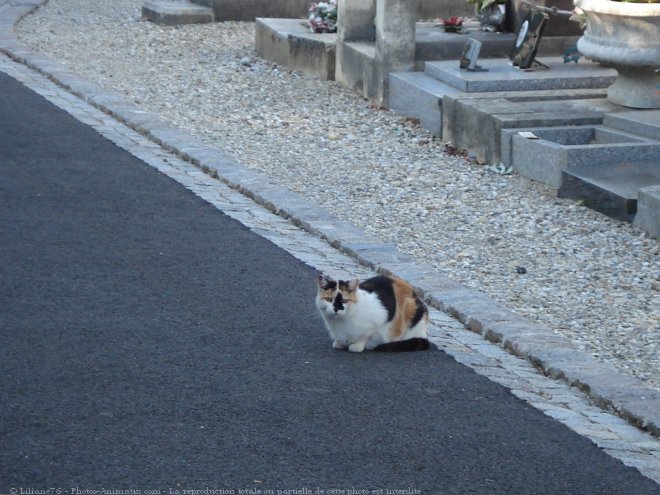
[575,0,660,108]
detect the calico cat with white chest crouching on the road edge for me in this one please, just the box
[316,275,430,352]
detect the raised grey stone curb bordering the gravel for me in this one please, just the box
[0,0,660,437]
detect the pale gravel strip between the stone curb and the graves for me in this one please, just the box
[17,0,660,389]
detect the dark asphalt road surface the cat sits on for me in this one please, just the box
[0,73,660,495]
